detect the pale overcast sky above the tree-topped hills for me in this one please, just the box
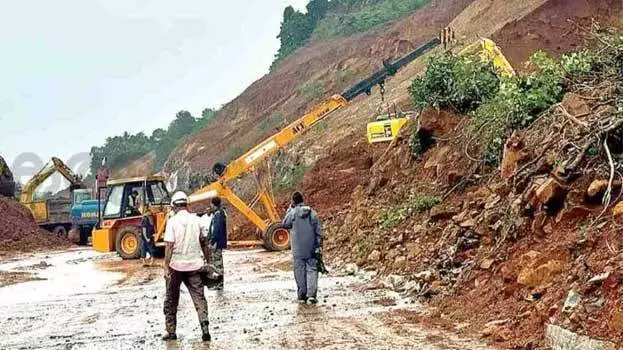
[0,0,307,186]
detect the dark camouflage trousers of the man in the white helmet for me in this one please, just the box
[164,269,208,333]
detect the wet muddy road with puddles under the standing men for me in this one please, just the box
[0,250,486,349]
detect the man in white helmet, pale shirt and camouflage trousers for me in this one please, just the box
[163,191,211,341]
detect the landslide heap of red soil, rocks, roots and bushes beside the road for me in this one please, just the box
[316,24,623,349]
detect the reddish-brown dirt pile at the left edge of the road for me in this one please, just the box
[0,196,70,256]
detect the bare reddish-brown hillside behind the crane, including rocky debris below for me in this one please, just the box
[158,0,623,349]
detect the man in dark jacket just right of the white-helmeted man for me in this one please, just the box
[208,197,227,290]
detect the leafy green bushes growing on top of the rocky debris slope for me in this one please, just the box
[409,42,600,164]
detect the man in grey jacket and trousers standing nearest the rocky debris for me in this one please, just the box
[283,192,322,304]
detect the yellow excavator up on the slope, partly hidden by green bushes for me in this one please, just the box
[367,37,515,143]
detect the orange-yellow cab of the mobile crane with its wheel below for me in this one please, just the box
[92,176,171,259]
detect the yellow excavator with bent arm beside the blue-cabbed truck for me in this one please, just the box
[20,157,91,236]
